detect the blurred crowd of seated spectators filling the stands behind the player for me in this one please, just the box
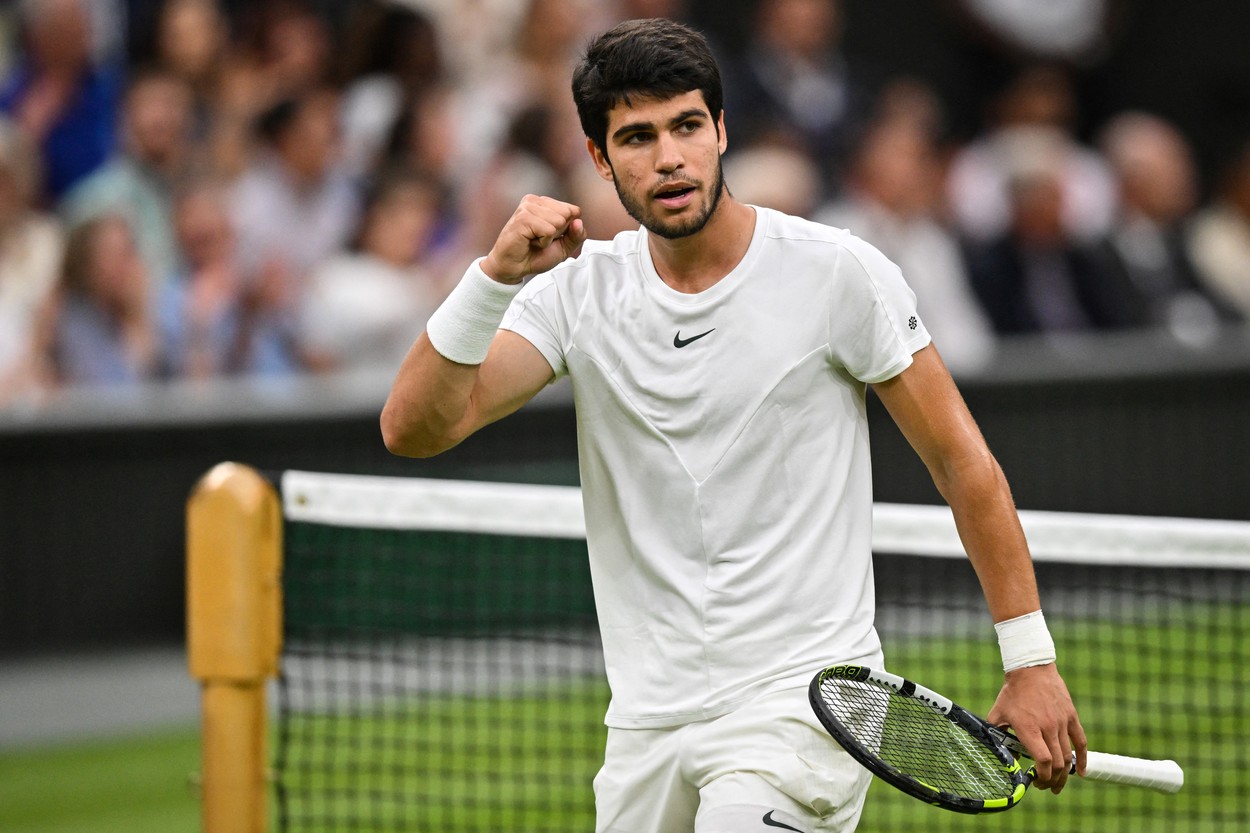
[0,0,1250,406]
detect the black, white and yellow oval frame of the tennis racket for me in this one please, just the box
[808,664,1034,813]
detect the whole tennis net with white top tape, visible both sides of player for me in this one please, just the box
[274,473,1250,833]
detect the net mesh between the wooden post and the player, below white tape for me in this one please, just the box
[275,523,608,833]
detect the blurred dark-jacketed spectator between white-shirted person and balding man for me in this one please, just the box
[969,142,1118,335]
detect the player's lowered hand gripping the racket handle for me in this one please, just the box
[989,663,1085,793]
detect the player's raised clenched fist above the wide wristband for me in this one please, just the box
[481,194,586,284]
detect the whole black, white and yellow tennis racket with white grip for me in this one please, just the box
[808,665,1185,813]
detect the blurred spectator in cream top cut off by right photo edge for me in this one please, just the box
[1190,145,1250,319]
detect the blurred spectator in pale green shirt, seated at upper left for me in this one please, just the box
[60,70,193,290]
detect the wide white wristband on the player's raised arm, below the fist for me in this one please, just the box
[425,259,521,364]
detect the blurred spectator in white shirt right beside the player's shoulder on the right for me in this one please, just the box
[815,114,994,373]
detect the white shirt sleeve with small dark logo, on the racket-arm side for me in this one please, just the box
[829,235,931,384]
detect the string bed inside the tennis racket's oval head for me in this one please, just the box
[821,679,1015,799]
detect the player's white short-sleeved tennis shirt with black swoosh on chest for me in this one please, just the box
[503,208,929,728]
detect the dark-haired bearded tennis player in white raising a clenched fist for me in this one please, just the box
[383,20,1085,833]
